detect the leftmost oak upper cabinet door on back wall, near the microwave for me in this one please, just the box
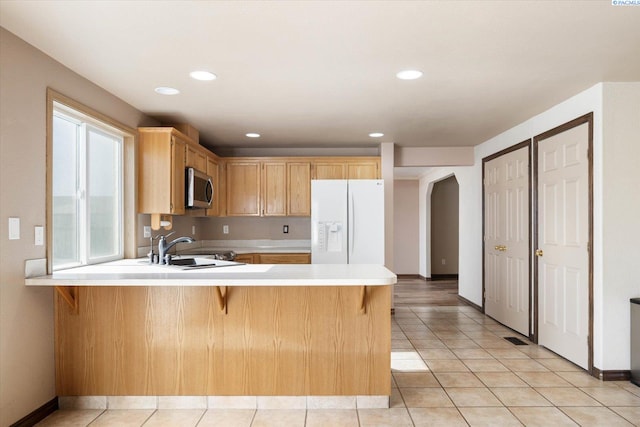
[227,162,260,216]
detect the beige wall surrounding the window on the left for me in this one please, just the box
[0,28,157,426]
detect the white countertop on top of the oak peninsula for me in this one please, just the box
[25,259,396,286]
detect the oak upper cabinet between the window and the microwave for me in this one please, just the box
[138,128,187,215]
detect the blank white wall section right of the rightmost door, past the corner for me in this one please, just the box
[596,83,640,370]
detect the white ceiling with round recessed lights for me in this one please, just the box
[0,0,640,157]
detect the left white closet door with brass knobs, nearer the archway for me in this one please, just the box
[484,147,530,336]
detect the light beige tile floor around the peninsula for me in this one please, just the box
[33,280,640,427]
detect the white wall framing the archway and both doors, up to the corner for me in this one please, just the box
[420,84,604,362]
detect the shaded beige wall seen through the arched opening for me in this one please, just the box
[431,176,459,275]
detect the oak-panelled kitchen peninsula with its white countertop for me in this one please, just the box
[26,259,396,406]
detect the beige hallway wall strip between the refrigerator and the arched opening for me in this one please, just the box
[393,180,420,274]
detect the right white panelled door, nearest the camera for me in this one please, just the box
[536,123,589,369]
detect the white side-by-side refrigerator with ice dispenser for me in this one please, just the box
[311,179,384,265]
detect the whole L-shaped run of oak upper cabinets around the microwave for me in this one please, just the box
[138,133,380,221]
